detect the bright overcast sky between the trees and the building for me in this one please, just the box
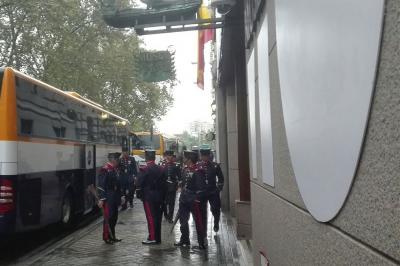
[142,31,212,134]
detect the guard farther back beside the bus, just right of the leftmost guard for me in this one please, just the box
[118,149,137,210]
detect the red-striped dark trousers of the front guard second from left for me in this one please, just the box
[143,201,162,242]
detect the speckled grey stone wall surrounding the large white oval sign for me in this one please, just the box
[251,0,400,265]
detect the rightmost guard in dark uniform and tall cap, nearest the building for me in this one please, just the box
[199,148,224,232]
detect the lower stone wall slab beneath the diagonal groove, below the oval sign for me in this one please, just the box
[251,183,395,266]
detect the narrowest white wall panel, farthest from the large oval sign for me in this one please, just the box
[247,51,257,178]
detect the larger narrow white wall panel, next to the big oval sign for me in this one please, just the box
[257,14,274,186]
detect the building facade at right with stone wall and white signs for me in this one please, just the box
[216,0,400,265]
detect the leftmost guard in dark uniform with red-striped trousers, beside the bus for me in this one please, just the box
[97,153,121,244]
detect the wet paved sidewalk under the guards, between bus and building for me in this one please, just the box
[14,200,247,266]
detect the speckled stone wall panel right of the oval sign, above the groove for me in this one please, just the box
[332,0,400,258]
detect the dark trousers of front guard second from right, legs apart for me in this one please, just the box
[179,201,206,245]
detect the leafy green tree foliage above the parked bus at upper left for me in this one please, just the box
[0,0,175,130]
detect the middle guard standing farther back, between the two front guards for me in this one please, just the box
[161,150,181,223]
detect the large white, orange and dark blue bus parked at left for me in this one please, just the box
[0,68,128,234]
